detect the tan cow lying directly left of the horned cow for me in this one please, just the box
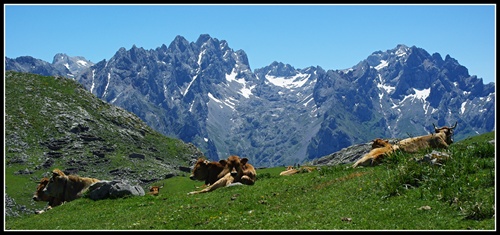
[352,138,398,168]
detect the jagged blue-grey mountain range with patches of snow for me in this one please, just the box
[6,34,495,167]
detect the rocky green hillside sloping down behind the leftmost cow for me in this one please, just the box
[4,72,203,215]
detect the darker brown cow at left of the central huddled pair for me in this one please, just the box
[189,158,226,186]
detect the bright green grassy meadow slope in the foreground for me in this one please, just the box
[5,132,496,230]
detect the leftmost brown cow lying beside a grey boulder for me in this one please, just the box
[43,169,100,202]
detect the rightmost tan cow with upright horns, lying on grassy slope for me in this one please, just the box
[397,122,457,153]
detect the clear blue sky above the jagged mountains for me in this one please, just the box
[4,4,496,83]
